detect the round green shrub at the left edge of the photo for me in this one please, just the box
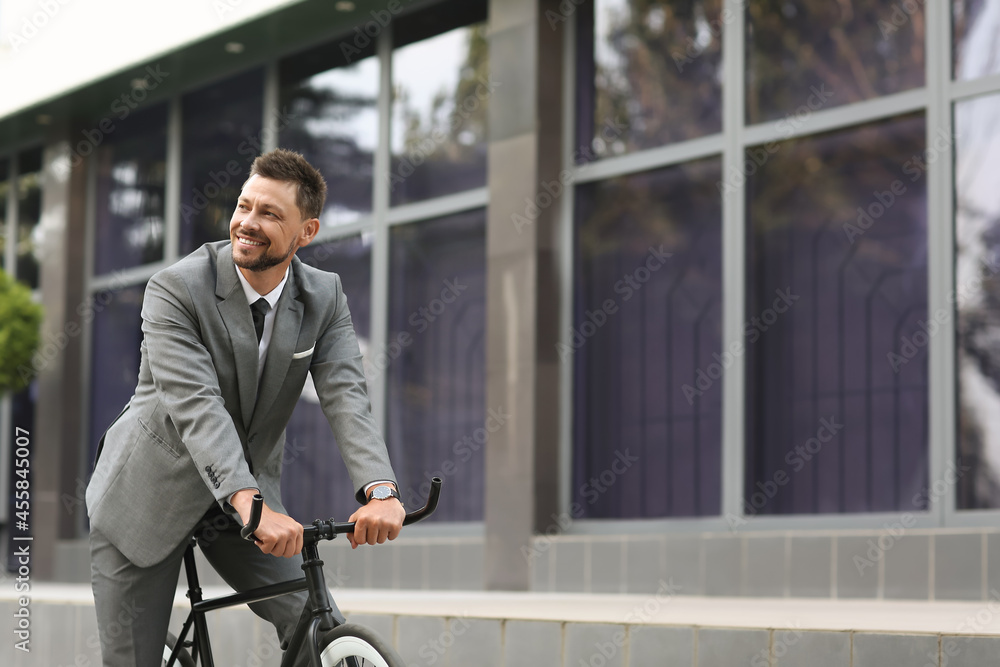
[0,271,42,394]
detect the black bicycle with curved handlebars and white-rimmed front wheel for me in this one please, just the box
[162,477,441,667]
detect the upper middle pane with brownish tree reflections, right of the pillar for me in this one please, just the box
[746,0,926,124]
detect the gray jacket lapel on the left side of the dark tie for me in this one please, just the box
[215,245,258,428]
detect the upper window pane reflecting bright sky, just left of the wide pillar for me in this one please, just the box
[389,23,492,205]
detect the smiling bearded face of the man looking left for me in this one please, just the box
[229,174,319,271]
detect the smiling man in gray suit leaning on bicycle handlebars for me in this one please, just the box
[87,149,404,667]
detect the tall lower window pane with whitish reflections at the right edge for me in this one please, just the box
[955,95,1000,509]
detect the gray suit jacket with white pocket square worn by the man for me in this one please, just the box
[87,241,395,567]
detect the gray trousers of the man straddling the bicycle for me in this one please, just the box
[90,505,344,667]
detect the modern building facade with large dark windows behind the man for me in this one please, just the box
[0,0,1000,599]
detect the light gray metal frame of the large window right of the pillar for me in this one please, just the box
[559,0,980,535]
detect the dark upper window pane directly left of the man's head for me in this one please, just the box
[179,70,264,255]
